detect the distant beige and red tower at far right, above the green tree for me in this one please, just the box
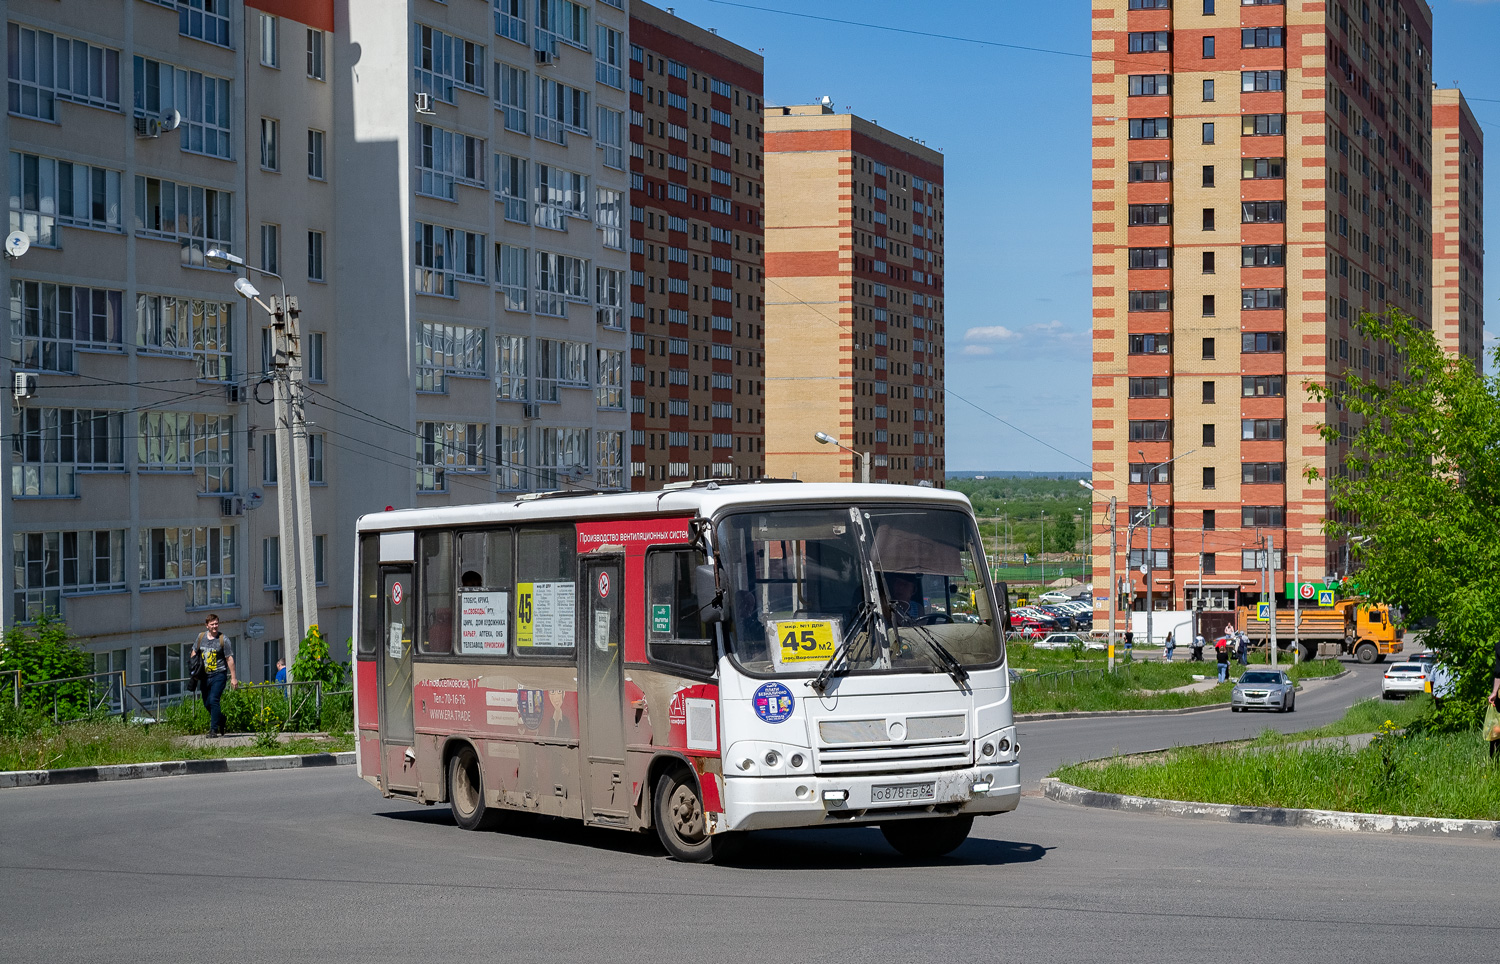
[1433,88,1485,372]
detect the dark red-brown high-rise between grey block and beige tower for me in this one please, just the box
[630,3,765,489]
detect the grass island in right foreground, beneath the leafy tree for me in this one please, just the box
[1053,696,1500,820]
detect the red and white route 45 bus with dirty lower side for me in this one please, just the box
[354,480,1020,862]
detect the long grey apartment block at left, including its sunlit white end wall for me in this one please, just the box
[0,0,630,694]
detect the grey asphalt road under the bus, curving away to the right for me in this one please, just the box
[0,667,1500,964]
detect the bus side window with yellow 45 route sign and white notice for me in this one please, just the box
[510,526,578,657]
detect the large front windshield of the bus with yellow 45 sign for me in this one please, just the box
[719,505,1002,675]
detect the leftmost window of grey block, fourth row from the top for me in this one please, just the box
[11,408,125,498]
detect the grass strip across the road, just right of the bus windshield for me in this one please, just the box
[1007,642,1343,714]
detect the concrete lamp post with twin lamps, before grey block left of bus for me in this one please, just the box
[204,247,318,666]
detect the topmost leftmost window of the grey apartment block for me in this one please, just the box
[6,24,120,120]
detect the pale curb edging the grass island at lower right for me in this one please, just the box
[1041,777,1500,840]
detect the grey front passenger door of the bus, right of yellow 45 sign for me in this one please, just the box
[579,555,630,825]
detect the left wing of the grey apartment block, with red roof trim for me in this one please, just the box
[0,0,340,691]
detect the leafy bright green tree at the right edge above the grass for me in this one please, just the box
[1308,310,1500,729]
